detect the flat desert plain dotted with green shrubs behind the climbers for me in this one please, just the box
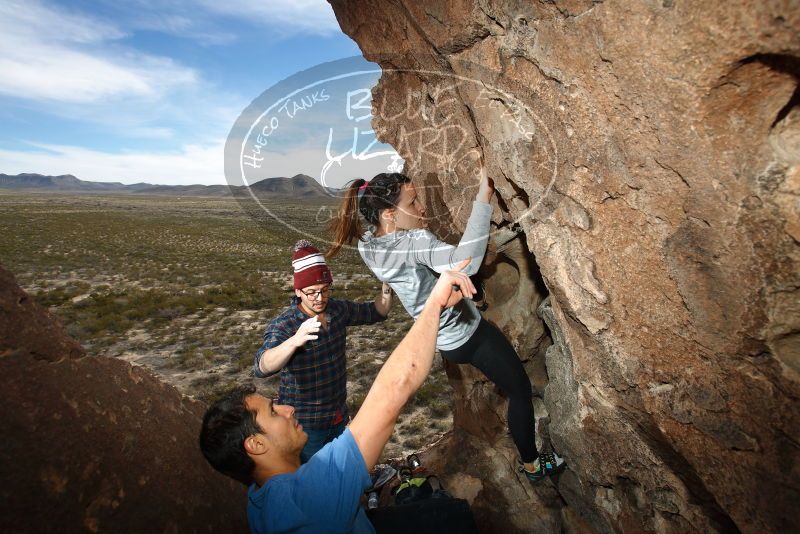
[0,191,452,458]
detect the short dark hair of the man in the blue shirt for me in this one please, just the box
[200,385,263,486]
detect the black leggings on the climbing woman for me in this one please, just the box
[441,319,539,463]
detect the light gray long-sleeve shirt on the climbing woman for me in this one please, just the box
[358,200,492,350]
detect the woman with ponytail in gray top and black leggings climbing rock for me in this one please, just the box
[327,171,565,481]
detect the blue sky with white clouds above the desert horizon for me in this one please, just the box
[0,0,398,185]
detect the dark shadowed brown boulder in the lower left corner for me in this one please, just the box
[0,267,247,533]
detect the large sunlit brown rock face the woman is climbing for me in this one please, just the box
[331,0,800,532]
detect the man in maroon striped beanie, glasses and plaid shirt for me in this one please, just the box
[255,239,392,463]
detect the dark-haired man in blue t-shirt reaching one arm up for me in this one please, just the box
[200,259,475,534]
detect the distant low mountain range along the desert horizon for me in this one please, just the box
[0,173,339,199]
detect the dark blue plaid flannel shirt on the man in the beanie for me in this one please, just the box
[255,297,385,430]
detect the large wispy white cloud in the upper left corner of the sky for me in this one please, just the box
[0,0,197,103]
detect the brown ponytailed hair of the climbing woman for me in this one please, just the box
[325,172,411,257]
